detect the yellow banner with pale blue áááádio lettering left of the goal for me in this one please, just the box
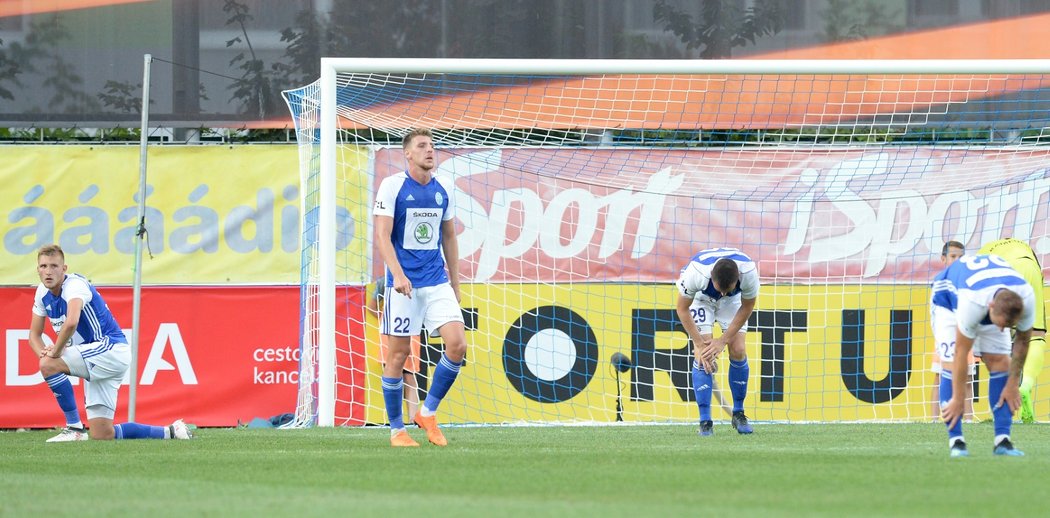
[0,145,371,285]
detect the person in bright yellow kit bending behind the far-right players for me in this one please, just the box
[978,237,1047,422]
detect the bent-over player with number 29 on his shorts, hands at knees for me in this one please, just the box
[675,248,759,435]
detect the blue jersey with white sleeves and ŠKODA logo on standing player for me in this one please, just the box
[373,171,455,288]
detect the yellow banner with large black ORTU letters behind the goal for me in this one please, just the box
[356,284,1037,423]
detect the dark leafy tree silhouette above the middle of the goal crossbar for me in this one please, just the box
[653,0,781,59]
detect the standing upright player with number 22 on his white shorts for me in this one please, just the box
[373,129,466,447]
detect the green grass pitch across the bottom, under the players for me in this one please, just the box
[0,423,1050,518]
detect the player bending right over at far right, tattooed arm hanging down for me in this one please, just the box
[930,255,1035,457]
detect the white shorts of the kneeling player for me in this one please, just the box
[62,339,131,419]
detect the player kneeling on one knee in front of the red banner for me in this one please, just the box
[29,245,191,442]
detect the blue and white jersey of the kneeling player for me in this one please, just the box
[33,273,128,344]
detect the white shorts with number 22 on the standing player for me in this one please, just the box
[379,283,463,336]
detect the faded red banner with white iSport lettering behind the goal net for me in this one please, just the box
[375,146,1050,284]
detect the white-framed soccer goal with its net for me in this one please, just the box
[286,59,1050,426]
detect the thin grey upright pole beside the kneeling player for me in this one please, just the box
[128,54,153,421]
